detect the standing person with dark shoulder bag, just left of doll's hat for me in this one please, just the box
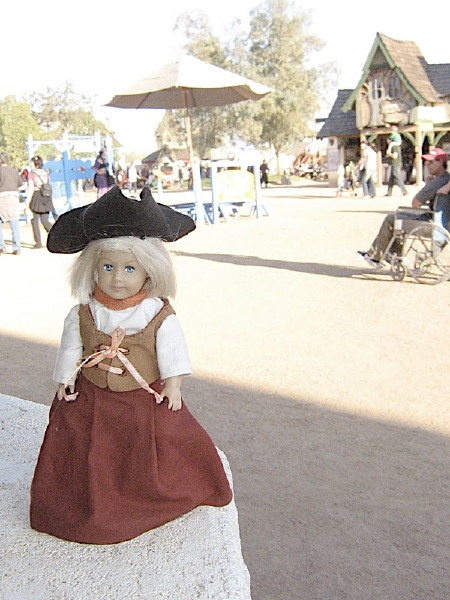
[27,156,56,250]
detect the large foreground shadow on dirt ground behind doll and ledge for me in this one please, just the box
[0,336,450,600]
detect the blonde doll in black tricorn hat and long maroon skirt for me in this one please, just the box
[30,187,232,544]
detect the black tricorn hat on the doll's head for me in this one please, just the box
[47,186,195,254]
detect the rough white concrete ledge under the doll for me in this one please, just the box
[0,394,250,600]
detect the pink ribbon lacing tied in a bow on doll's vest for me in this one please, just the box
[66,325,163,404]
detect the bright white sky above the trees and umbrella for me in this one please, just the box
[0,0,450,155]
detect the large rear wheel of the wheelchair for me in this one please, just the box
[403,223,450,285]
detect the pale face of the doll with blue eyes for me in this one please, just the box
[97,251,148,300]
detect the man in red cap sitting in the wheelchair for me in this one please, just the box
[358,148,450,266]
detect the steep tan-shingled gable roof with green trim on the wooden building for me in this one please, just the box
[342,33,439,111]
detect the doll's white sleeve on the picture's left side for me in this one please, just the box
[53,304,83,384]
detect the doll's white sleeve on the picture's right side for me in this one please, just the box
[156,315,192,379]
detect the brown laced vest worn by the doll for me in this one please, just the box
[78,299,175,392]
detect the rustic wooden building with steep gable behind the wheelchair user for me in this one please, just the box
[317,33,450,185]
